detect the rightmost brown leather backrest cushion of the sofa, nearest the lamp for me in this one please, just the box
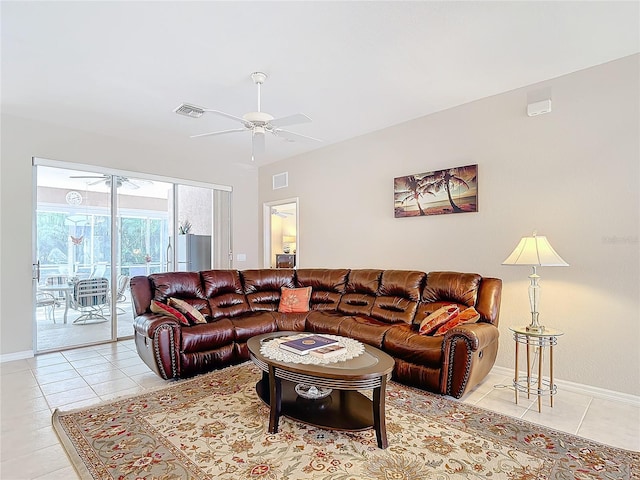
[422,272,482,307]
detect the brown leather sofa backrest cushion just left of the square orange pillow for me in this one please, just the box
[240,269,295,312]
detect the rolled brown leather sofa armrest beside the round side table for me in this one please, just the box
[440,322,500,398]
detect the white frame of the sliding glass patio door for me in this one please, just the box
[31,157,233,353]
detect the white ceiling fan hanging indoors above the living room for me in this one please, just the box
[174,72,322,160]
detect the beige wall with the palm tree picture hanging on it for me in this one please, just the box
[259,55,640,395]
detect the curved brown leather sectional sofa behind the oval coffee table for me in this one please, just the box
[131,269,502,398]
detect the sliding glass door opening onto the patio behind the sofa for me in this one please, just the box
[33,159,231,352]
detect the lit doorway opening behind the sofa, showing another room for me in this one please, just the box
[263,198,300,268]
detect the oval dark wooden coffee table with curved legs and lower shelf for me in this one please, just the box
[247,332,394,448]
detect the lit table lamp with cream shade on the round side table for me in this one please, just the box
[502,232,569,333]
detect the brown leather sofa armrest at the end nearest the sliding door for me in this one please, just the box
[133,313,181,380]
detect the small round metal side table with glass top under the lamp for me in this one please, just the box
[509,326,564,412]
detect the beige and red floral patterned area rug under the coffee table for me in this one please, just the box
[53,362,640,480]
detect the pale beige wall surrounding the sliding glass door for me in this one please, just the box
[0,115,259,358]
